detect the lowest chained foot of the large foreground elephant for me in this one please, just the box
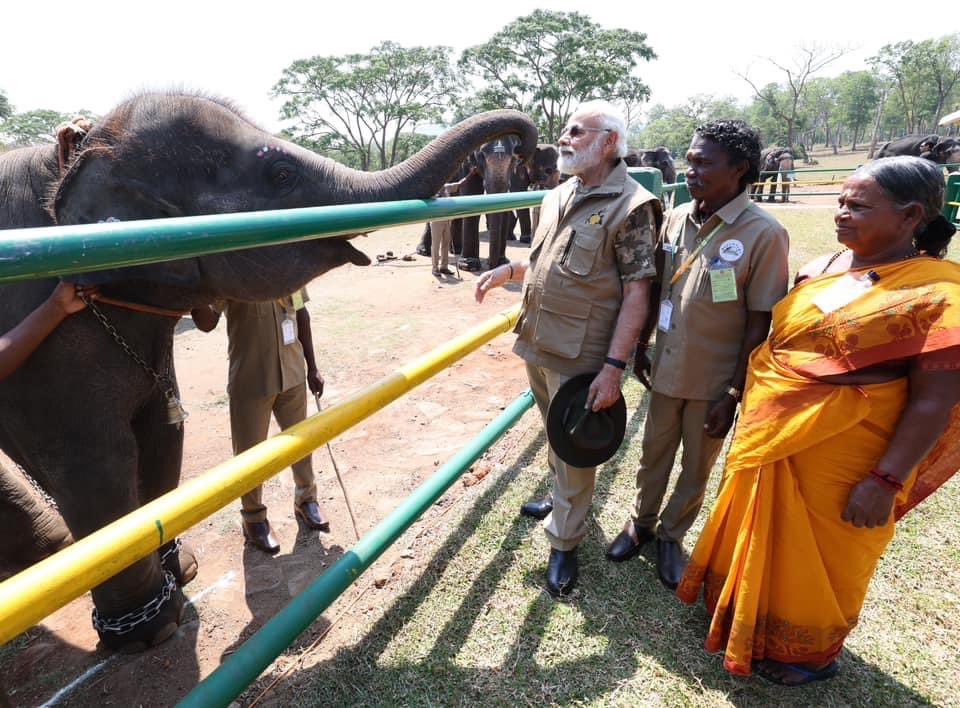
[93,571,185,654]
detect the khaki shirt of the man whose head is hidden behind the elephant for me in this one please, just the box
[218,288,310,398]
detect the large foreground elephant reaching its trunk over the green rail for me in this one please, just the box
[0,92,537,651]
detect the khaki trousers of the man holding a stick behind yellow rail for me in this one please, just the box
[230,383,317,522]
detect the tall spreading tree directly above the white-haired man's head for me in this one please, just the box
[459,10,657,141]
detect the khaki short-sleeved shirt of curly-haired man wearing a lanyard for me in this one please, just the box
[651,192,789,401]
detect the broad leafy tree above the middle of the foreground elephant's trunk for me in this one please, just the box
[273,42,459,170]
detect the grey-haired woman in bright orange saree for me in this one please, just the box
[677,158,960,685]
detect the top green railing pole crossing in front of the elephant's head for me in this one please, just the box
[0,191,546,282]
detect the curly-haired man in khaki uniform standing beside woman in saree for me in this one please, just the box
[607,121,789,589]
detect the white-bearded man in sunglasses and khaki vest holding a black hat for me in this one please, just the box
[475,101,662,597]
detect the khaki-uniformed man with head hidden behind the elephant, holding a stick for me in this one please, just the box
[193,289,330,553]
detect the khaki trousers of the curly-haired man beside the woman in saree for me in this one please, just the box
[633,391,723,543]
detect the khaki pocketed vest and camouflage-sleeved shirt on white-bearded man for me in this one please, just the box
[513,160,661,376]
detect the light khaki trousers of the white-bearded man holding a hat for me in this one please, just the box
[527,364,597,551]
